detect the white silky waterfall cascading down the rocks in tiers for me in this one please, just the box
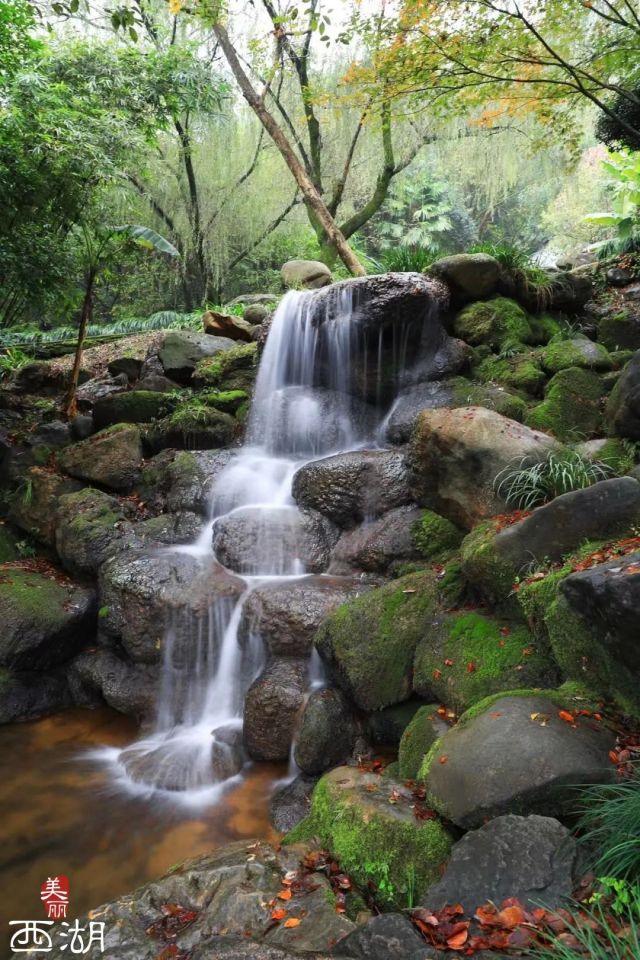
[106,284,444,802]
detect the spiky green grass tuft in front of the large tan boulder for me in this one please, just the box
[494,450,613,510]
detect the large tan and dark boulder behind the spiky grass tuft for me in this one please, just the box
[407,407,557,529]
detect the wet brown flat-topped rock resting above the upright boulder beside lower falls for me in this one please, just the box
[240,576,368,657]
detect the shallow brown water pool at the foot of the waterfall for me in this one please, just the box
[0,709,284,956]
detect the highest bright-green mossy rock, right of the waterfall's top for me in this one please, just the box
[453,297,535,350]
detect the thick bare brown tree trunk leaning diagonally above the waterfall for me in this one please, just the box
[214,24,366,277]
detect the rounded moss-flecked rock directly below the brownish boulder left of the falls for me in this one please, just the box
[56,487,136,576]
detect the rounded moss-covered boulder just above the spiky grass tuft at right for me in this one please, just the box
[524,367,606,440]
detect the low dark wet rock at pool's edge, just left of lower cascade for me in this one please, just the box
[68,647,160,721]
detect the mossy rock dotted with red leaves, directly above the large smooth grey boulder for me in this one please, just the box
[414,611,558,711]
